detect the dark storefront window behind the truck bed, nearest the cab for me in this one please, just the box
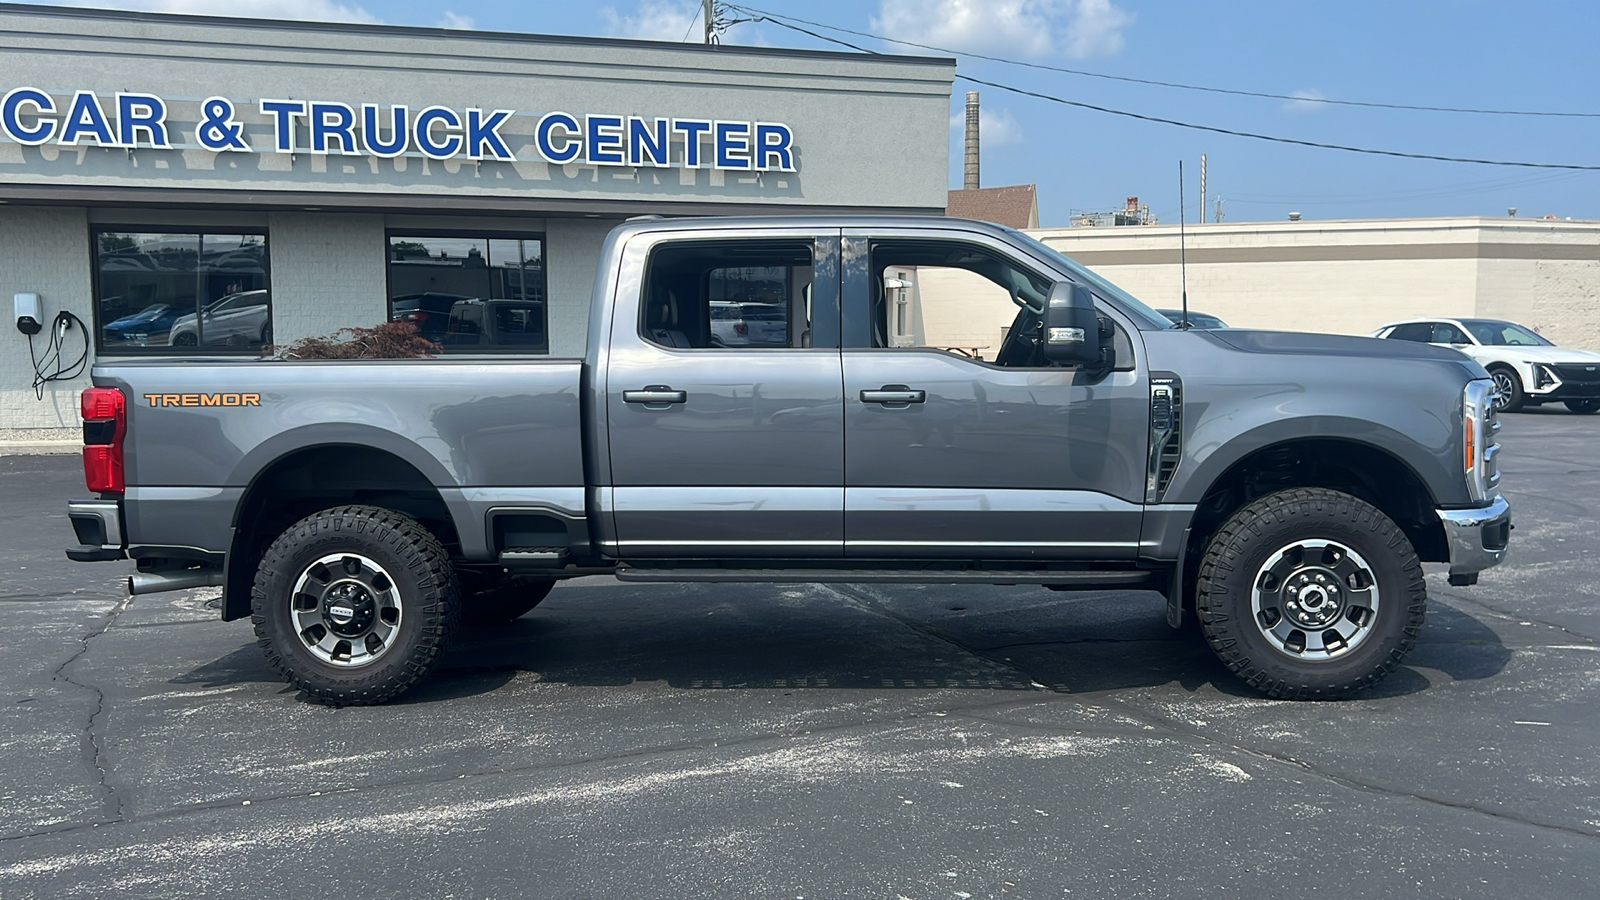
[389,234,550,354]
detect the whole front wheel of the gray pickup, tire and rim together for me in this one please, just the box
[1195,488,1427,700]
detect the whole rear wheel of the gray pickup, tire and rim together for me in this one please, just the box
[250,506,461,706]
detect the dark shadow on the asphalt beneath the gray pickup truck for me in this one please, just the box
[174,586,1510,705]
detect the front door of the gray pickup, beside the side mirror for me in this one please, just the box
[842,229,1149,560]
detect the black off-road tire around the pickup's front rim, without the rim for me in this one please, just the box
[1195,488,1427,700]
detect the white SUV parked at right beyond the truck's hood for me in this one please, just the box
[1373,319,1600,413]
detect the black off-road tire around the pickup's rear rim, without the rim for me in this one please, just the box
[250,506,461,706]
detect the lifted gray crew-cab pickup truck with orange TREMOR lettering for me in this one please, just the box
[67,216,1510,705]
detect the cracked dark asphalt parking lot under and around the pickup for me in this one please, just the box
[0,410,1600,900]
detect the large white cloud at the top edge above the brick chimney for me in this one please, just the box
[872,0,1133,59]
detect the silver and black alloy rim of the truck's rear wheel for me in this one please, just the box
[288,552,400,668]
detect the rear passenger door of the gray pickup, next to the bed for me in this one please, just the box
[602,229,845,559]
